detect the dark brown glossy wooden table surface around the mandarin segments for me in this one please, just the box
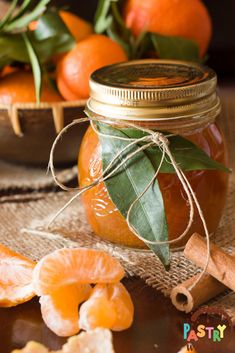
[0,87,235,353]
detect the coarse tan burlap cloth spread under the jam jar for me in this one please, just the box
[0,177,235,320]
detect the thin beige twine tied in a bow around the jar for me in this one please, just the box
[47,116,210,290]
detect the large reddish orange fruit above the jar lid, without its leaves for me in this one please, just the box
[124,0,212,57]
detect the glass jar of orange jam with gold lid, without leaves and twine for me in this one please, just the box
[78,60,228,248]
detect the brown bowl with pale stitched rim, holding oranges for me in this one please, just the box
[0,100,88,166]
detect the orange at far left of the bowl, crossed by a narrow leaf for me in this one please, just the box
[0,71,63,104]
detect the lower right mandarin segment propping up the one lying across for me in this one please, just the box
[79,283,134,331]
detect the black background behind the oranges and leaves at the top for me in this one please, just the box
[52,0,235,80]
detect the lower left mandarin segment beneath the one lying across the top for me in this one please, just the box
[40,284,91,337]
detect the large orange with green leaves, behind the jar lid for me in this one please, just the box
[95,0,212,61]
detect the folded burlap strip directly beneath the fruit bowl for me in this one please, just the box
[0,161,77,191]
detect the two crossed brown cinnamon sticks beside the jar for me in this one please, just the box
[171,233,235,312]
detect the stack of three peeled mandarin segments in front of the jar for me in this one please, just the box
[33,248,134,336]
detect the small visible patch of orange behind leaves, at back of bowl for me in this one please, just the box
[59,10,93,42]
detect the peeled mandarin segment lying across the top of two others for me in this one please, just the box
[33,248,124,295]
